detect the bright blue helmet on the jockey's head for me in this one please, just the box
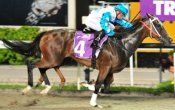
[114,3,128,16]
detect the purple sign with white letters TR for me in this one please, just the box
[140,0,175,21]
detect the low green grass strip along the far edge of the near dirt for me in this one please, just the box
[0,81,174,95]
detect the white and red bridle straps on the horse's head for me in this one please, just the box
[140,17,162,39]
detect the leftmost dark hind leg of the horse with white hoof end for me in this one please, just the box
[22,61,34,94]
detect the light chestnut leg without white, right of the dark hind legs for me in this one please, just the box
[54,67,66,90]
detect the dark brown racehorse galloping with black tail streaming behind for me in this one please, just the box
[3,14,172,106]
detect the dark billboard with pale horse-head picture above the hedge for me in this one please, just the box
[0,0,68,27]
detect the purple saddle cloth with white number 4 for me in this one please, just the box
[74,31,108,58]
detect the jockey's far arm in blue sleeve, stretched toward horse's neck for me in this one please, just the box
[113,19,133,28]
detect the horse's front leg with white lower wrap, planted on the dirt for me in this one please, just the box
[90,68,109,108]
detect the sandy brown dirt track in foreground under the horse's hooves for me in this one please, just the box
[0,91,175,110]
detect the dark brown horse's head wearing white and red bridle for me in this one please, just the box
[142,14,173,45]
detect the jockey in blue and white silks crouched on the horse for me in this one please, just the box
[85,3,132,68]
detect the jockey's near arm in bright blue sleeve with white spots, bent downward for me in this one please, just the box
[100,12,115,37]
